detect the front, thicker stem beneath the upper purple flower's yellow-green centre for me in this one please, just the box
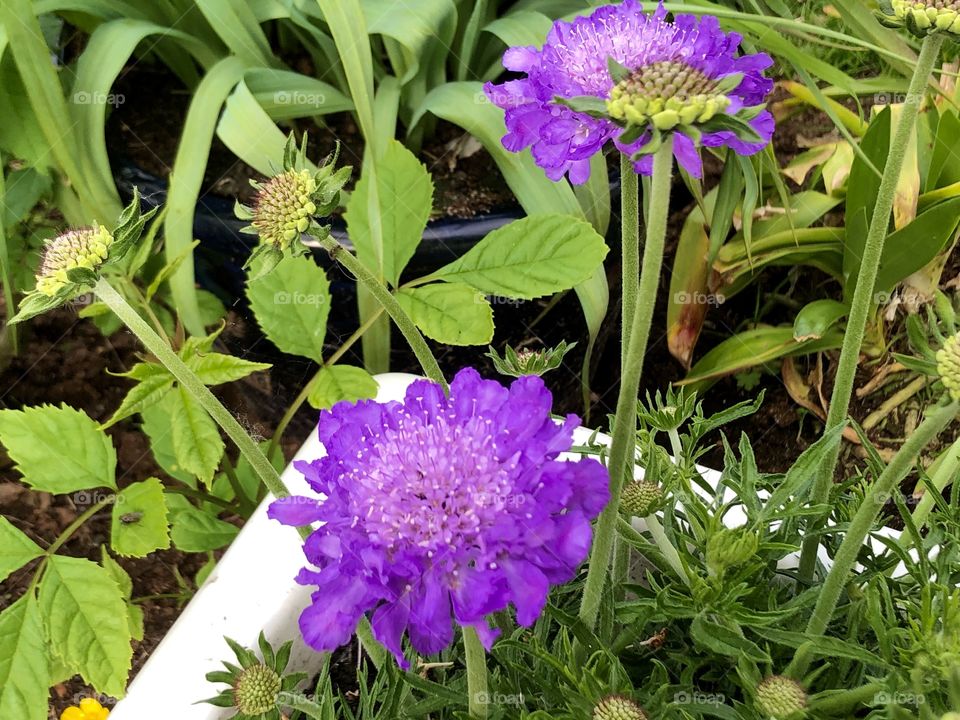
[580,135,673,629]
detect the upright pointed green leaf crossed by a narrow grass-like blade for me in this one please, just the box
[346,140,433,286]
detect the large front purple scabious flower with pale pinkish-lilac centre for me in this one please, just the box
[269,368,609,668]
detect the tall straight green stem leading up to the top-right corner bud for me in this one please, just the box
[798,33,943,585]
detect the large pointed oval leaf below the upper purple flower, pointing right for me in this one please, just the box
[431,215,608,300]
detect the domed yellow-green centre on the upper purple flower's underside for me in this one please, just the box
[607,60,730,130]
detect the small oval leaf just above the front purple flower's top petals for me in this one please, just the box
[397,282,493,345]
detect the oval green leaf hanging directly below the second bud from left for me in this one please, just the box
[247,257,330,363]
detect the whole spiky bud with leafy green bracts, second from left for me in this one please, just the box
[234,135,352,277]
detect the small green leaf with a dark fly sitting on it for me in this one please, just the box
[110,478,170,557]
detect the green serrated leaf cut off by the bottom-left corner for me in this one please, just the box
[0,593,50,720]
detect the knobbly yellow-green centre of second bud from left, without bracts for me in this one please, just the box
[250,170,317,250]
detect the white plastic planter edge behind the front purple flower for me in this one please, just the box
[110,373,902,720]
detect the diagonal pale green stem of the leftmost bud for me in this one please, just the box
[93,278,290,506]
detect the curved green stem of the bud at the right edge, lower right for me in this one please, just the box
[788,401,960,678]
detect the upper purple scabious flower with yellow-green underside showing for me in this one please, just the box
[484,0,774,184]
